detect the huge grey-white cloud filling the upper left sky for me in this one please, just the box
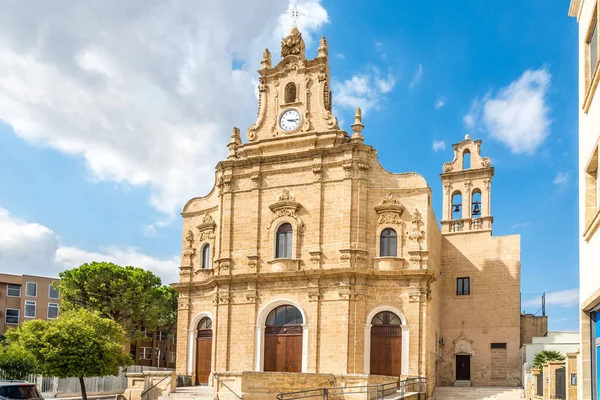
[0,0,328,214]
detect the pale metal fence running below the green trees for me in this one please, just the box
[0,365,173,397]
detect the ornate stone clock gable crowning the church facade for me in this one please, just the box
[244,26,340,156]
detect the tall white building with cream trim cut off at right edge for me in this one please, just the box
[569,0,600,400]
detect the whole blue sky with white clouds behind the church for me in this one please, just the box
[0,0,578,331]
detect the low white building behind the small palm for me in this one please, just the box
[521,332,580,382]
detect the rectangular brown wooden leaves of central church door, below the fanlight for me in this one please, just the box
[264,333,302,372]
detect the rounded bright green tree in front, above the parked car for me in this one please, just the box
[6,309,131,400]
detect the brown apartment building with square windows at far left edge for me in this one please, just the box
[0,274,60,335]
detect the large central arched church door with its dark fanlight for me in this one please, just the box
[264,305,303,372]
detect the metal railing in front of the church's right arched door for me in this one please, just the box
[276,377,427,400]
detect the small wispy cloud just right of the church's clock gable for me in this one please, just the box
[331,66,396,114]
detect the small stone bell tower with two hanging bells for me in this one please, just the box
[440,135,494,234]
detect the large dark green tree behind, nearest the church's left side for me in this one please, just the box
[59,262,177,341]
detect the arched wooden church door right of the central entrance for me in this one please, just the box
[370,311,402,376]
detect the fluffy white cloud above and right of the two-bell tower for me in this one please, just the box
[463,68,551,154]
